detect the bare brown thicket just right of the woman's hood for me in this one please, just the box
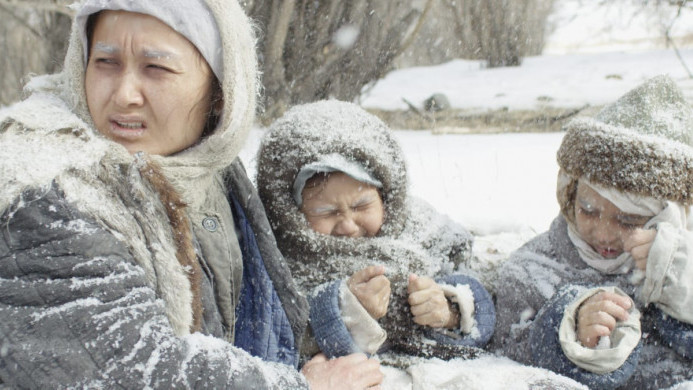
[245,0,432,121]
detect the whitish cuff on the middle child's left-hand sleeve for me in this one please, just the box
[339,281,387,355]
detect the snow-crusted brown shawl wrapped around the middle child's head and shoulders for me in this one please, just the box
[257,101,472,288]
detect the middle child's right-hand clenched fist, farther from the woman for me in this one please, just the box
[408,274,459,328]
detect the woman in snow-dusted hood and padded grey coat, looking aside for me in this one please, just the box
[0,0,382,388]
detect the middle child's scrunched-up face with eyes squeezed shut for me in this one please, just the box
[301,172,385,237]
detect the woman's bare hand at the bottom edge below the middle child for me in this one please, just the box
[301,353,383,390]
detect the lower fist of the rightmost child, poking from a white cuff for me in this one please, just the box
[577,291,633,348]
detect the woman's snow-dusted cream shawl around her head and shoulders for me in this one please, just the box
[0,0,257,334]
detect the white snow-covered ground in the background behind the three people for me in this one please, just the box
[241,0,693,266]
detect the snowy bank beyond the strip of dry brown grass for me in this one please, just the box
[360,49,693,110]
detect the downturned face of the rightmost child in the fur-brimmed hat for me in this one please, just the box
[575,183,650,259]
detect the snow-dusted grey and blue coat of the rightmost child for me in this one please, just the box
[490,216,693,389]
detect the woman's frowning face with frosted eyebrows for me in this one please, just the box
[85,11,213,156]
